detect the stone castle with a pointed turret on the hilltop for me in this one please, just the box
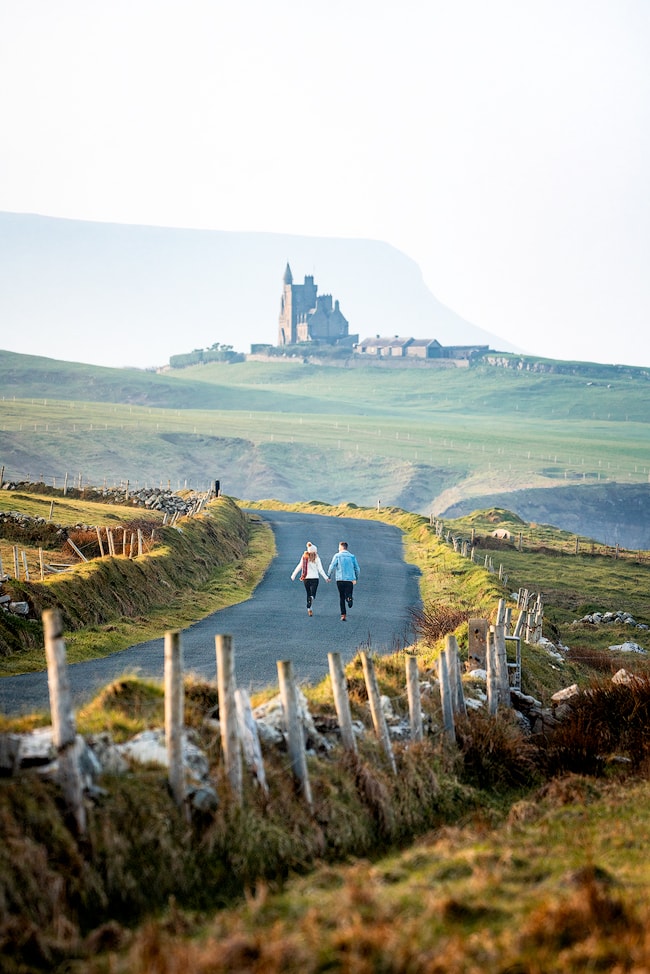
[278,264,359,346]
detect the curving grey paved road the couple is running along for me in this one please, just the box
[0,511,419,714]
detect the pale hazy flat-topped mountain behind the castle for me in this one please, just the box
[0,213,514,368]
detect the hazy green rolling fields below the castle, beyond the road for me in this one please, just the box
[0,352,650,528]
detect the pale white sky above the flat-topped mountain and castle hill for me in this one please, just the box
[0,0,650,366]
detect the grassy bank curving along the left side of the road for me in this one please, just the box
[0,497,275,675]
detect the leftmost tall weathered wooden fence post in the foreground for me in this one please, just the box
[43,609,86,835]
